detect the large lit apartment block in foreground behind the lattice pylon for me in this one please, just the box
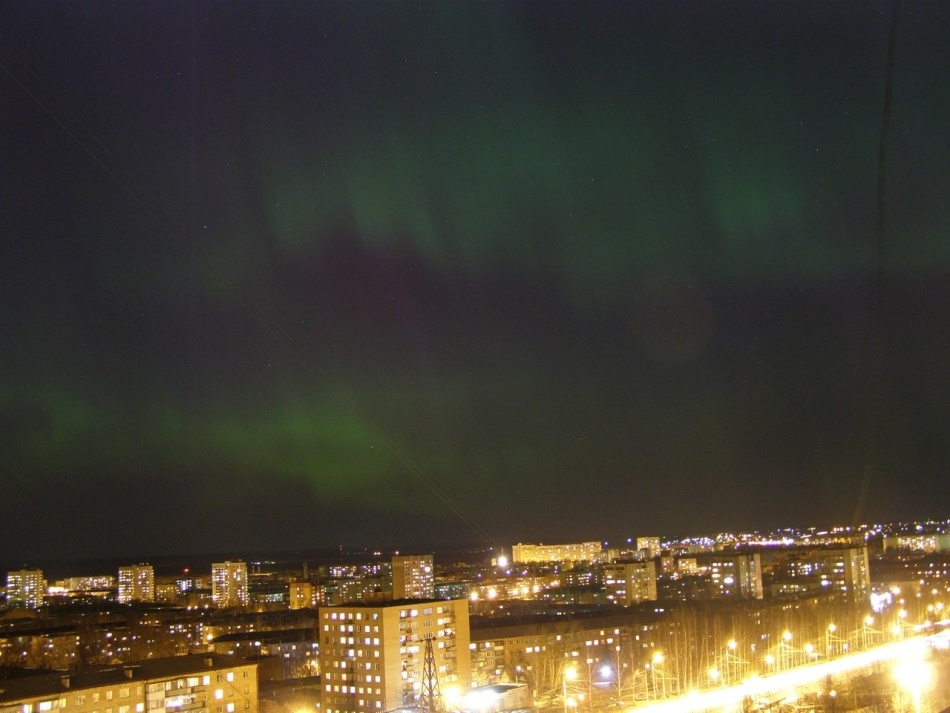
[318,599,471,713]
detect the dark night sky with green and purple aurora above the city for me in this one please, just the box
[0,0,950,561]
